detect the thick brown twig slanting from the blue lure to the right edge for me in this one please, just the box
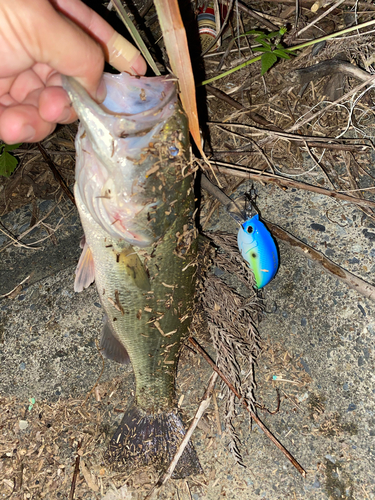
[263,219,375,300]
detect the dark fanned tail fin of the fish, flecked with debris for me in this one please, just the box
[106,404,202,479]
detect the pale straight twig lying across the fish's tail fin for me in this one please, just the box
[144,372,218,500]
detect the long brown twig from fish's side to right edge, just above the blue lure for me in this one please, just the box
[203,160,375,208]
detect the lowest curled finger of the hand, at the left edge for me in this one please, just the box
[0,104,55,144]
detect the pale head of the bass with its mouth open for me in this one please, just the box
[63,73,185,247]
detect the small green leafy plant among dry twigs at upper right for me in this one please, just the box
[242,27,290,76]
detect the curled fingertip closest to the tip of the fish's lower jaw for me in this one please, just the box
[39,87,77,123]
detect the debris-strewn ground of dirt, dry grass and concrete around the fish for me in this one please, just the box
[0,1,375,500]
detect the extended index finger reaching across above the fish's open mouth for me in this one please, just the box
[52,0,147,75]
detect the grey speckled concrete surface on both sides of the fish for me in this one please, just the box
[0,178,375,500]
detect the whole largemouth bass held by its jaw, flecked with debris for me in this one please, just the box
[63,73,201,478]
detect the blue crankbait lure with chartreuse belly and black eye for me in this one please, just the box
[237,214,279,288]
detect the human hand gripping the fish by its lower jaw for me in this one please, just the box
[0,0,146,144]
